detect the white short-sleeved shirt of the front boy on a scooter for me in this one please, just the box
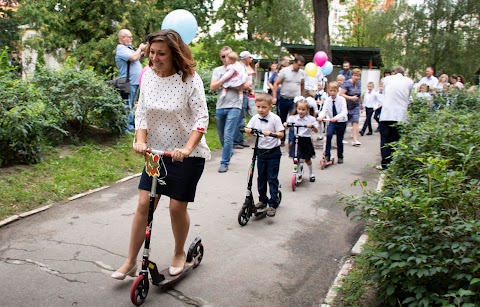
[247,112,285,149]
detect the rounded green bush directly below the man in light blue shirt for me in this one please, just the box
[33,61,127,139]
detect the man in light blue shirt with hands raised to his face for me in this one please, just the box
[115,29,146,131]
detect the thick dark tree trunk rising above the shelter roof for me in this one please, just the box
[312,0,332,61]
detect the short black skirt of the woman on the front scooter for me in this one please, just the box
[138,157,205,202]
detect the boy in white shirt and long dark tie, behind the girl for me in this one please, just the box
[317,81,348,164]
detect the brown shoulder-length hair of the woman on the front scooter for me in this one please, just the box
[145,29,195,82]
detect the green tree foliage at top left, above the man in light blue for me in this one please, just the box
[17,0,212,73]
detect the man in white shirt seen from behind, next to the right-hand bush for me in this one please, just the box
[380,66,413,169]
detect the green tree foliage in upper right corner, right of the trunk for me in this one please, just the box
[343,0,480,81]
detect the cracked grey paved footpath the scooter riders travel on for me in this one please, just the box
[0,125,379,307]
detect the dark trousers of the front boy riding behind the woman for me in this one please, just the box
[257,146,282,208]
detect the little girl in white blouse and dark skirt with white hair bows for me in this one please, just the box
[283,96,318,182]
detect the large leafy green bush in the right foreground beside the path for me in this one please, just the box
[344,93,480,306]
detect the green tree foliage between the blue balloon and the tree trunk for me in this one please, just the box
[197,0,313,64]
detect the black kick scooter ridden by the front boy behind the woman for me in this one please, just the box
[238,128,282,226]
